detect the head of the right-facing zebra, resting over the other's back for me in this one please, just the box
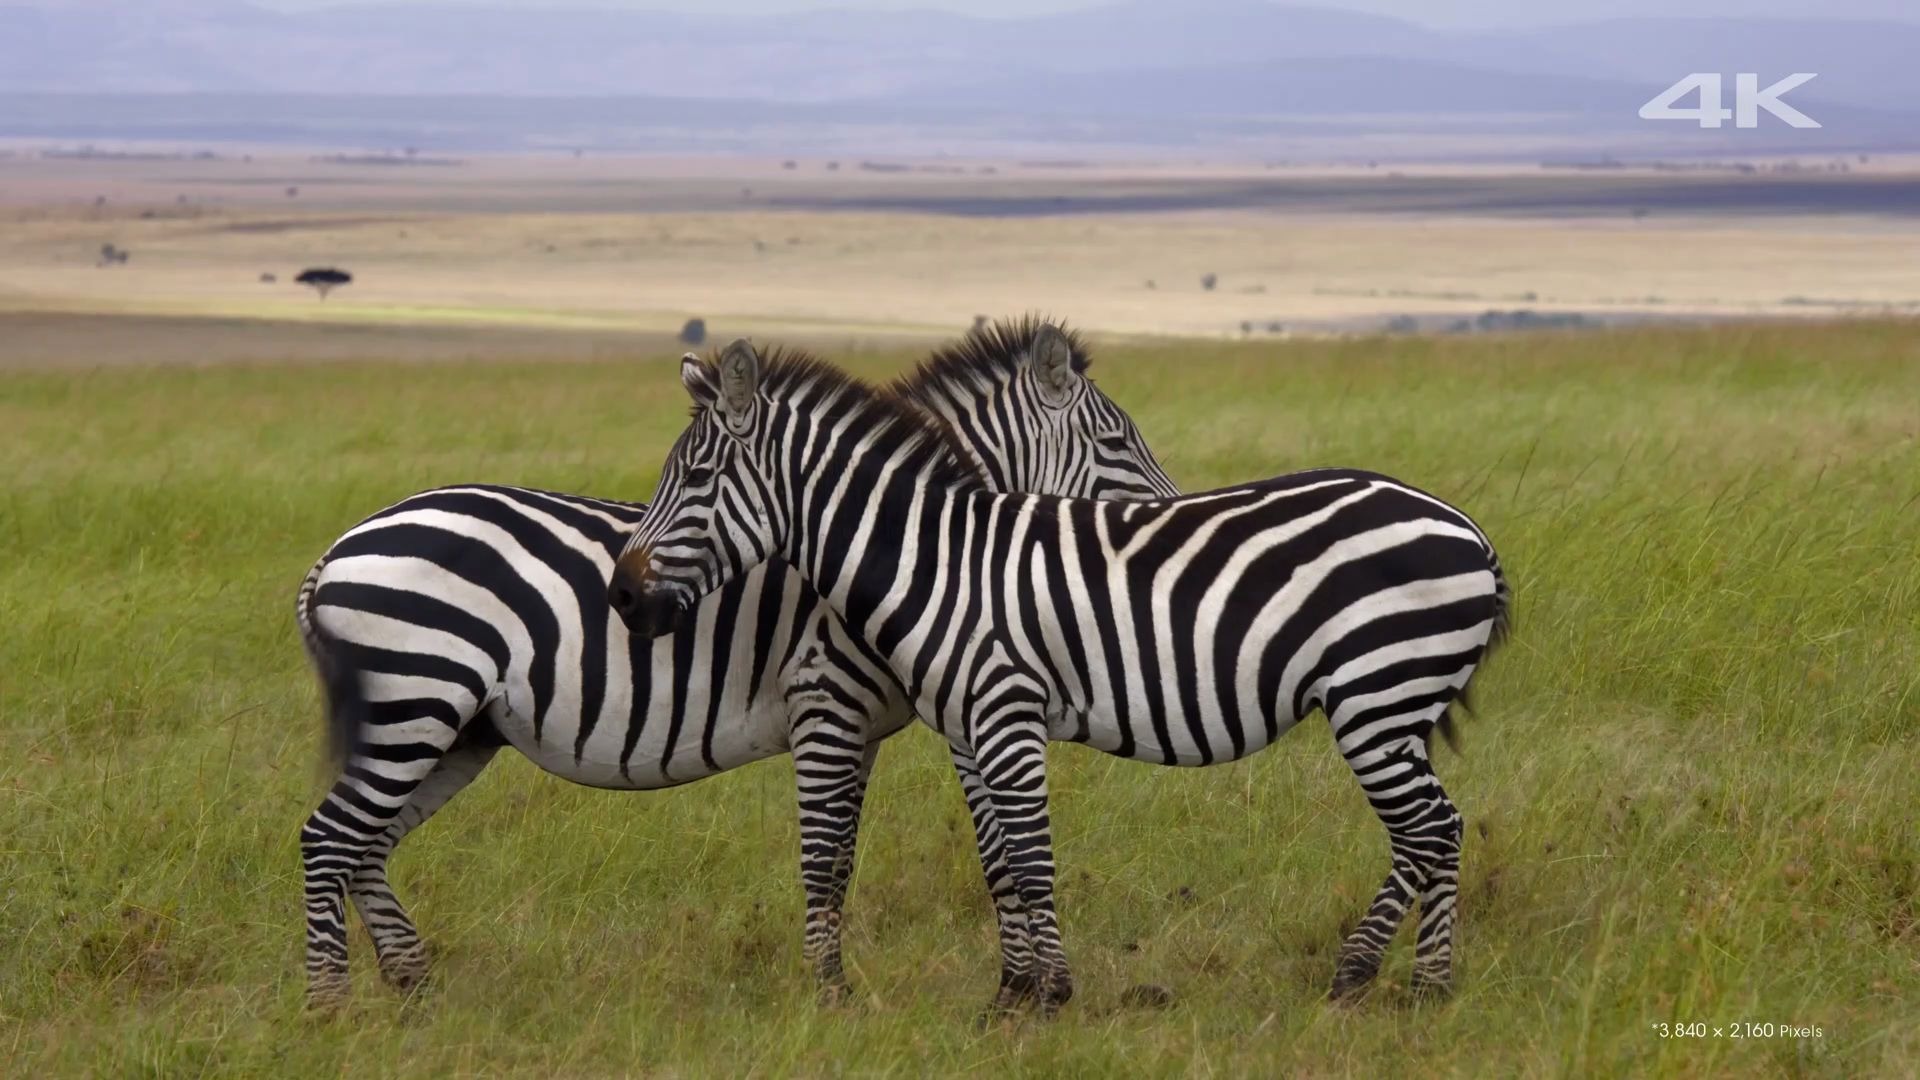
[893,317,1181,500]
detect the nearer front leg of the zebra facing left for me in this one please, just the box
[973,719,1073,1017]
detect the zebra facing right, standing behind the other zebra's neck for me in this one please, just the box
[296,319,1173,1007]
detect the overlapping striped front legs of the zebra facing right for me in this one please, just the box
[791,694,879,1005]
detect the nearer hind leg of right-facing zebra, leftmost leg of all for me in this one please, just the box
[300,705,453,1009]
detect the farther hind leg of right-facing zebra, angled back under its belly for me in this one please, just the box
[348,721,499,992]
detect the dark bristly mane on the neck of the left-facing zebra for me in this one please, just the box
[705,346,987,488]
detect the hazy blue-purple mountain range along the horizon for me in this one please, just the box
[0,0,1920,155]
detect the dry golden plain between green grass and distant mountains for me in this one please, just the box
[11,151,1920,343]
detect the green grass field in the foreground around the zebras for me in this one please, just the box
[0,323,1920,1076]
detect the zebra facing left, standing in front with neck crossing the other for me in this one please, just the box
[609,342,1511,1013]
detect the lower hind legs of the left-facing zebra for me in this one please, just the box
[1329,736,1461,999]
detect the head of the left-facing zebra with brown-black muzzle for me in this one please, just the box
[607,340,774,638]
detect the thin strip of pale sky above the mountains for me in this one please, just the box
[255,0,1916,27]
